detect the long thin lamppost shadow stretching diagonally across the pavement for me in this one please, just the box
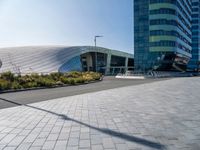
[0,98,167,150]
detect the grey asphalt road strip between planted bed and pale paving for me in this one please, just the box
[0,76,167,109]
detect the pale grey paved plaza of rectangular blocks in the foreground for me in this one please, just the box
[0,78,200,150]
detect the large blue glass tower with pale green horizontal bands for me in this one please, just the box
[134,0,192,72]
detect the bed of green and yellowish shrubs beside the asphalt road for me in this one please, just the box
[0,71,101,91]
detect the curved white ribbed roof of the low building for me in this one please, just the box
[0,46,133,73]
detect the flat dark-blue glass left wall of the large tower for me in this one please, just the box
[134,0,149,71]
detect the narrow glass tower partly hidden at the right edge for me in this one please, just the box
[188,0,200,71]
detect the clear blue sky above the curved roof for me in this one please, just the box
[0,0,133,53]
